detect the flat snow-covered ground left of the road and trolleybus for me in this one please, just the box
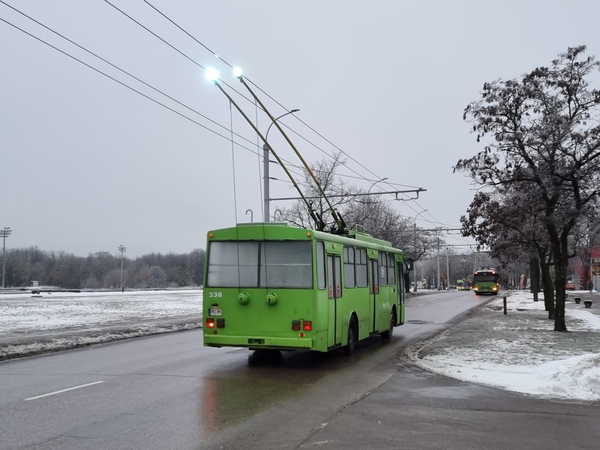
[0,290,202,359]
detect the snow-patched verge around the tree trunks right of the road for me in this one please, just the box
[407,292,600,401]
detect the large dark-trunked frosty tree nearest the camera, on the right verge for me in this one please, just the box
[455,46,600,331]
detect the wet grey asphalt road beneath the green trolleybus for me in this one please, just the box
[0,292,600,450]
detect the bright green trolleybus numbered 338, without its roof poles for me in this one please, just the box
[203,223,412,354]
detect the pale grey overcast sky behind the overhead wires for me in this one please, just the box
[0,0,600,257]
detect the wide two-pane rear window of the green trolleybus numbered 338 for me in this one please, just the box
[207,241,313,289]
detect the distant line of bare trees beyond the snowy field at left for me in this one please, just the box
[0,247,205,289]
